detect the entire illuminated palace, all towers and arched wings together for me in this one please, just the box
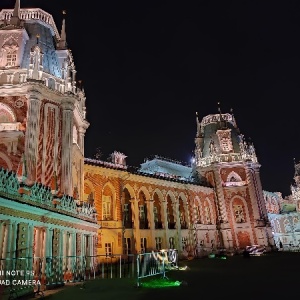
[0,0,300,290]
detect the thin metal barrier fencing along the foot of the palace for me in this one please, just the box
[0,250,178,299]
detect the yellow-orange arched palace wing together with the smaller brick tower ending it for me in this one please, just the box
[84,112,275,256]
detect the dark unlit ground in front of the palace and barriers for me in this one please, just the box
[6,253,300,300]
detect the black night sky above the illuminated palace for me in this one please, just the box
[0,0,300,196]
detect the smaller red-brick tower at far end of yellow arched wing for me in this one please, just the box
[194,108,274,248]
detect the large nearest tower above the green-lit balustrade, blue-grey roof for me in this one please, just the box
[0,0,89,199]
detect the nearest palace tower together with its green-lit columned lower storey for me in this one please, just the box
[0,0,99,296]
